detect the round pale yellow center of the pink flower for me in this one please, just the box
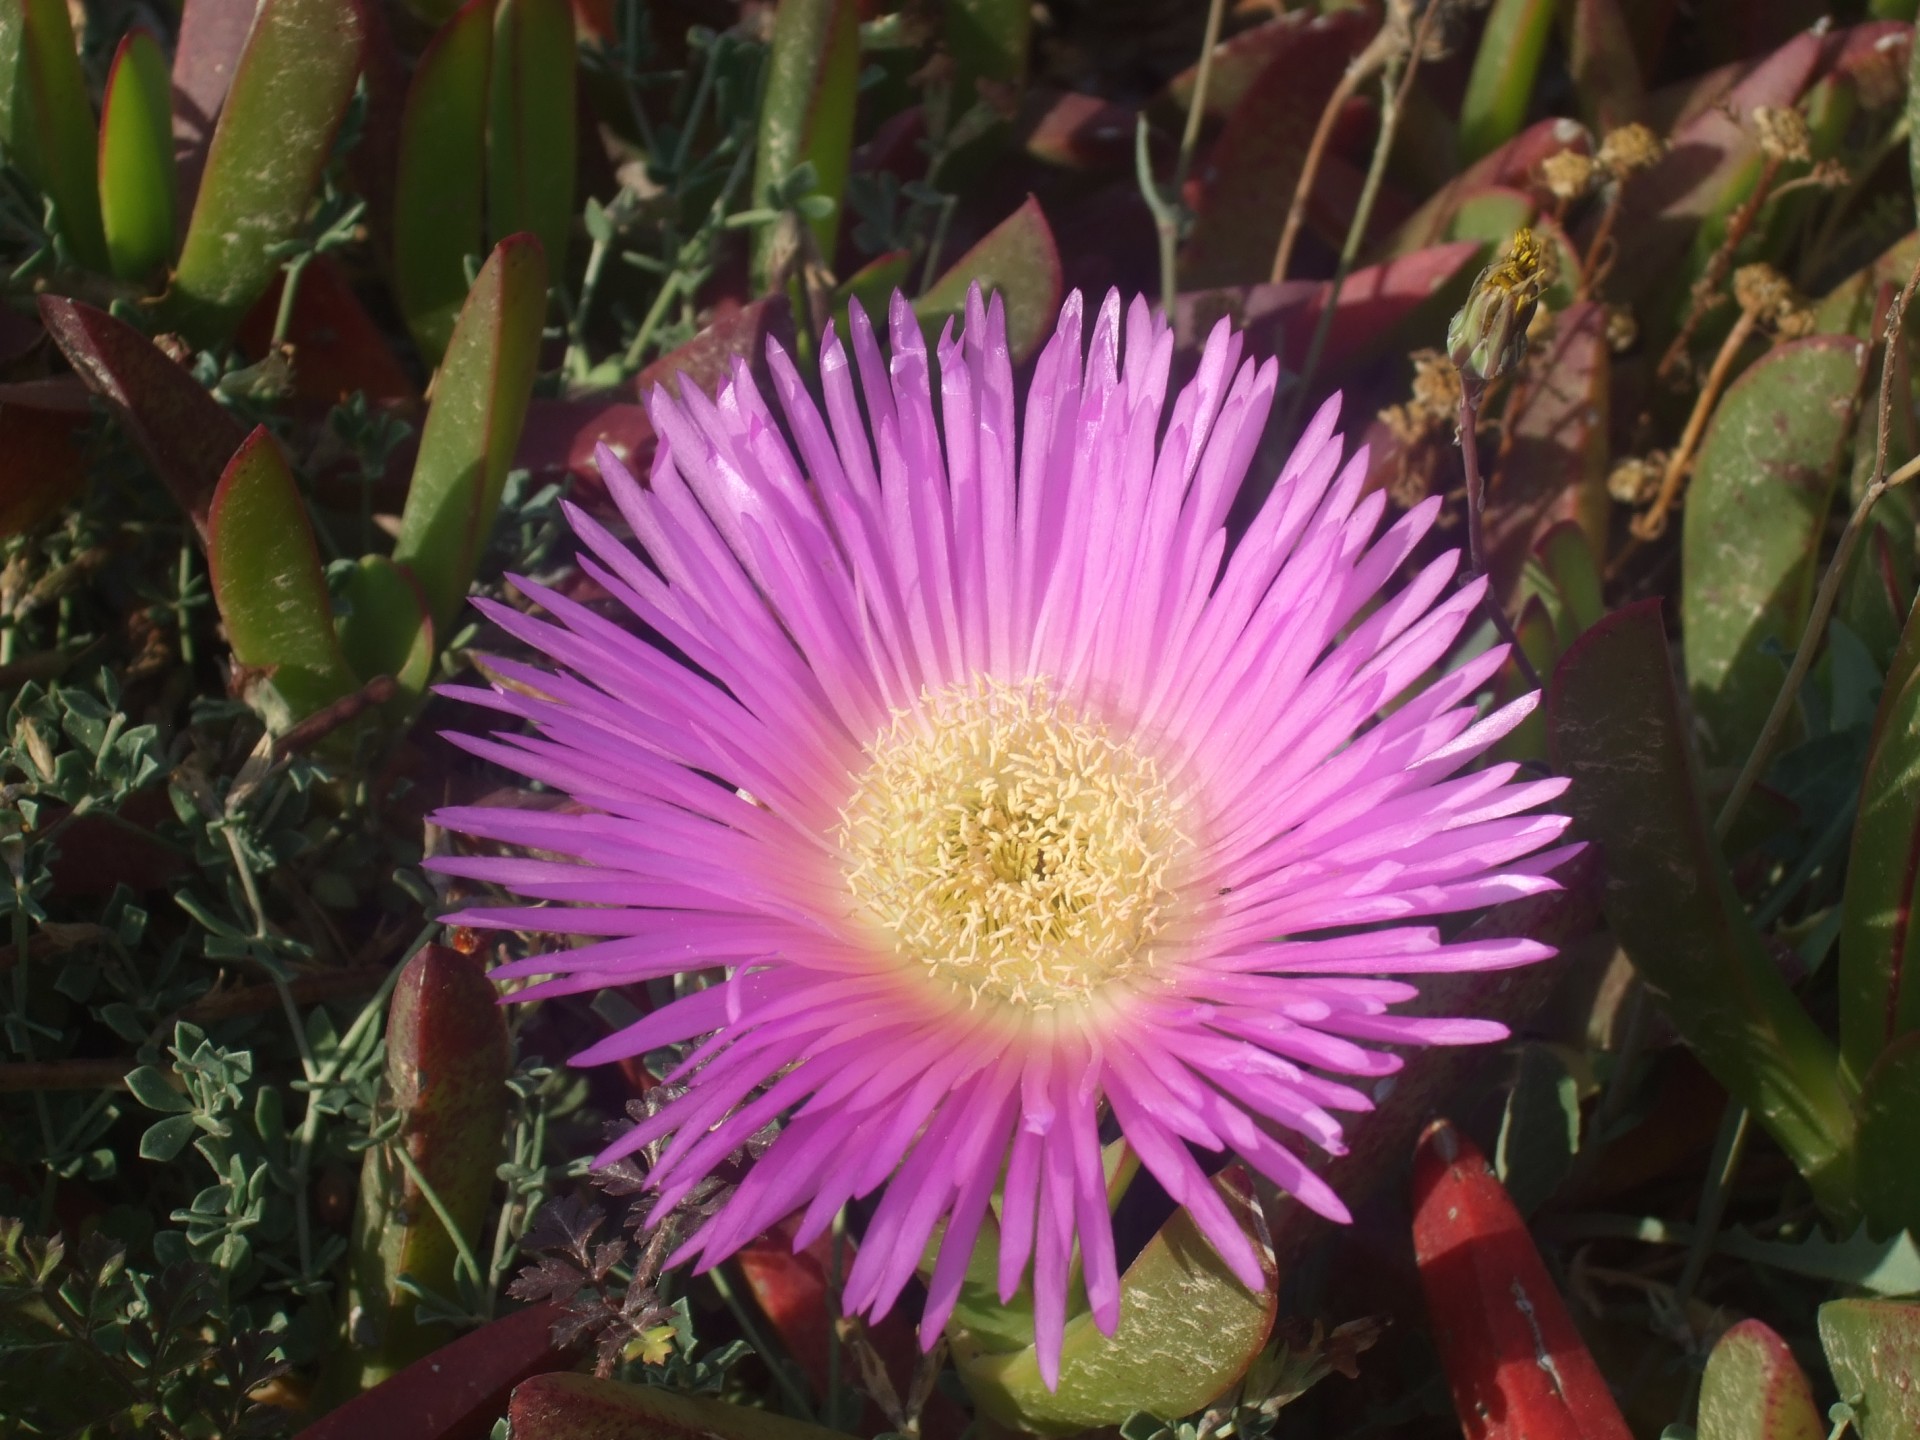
[837,678,1188,1010]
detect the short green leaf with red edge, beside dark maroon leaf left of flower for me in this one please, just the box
[207,426,355,730]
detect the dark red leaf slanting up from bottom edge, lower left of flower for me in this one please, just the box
[300,1304,572,1440]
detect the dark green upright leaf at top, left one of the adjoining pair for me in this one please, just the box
[394,0,493,365]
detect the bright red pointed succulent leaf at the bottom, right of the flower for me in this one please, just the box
[1413,1119,1632,1440]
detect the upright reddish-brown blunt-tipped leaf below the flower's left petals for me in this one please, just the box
[336,945,511,1392]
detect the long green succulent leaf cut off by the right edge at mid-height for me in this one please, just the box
[1839,579,1920,1090]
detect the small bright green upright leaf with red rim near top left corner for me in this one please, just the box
[100,31,177,280]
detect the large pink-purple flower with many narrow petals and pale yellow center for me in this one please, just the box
[438,292,1567,1382]
